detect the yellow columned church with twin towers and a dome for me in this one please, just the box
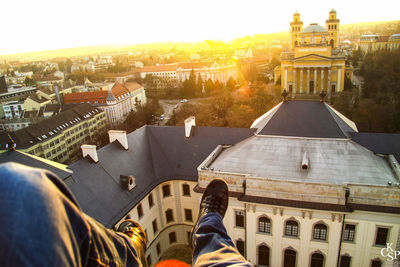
[275,10,352,98]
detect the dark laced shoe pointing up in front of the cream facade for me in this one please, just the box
[199,178,229,219]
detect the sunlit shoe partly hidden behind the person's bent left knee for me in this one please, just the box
[117,219,147,266]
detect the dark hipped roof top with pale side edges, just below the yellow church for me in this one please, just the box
[252,101,356,138]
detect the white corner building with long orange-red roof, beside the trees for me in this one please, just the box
[64,83,147,125]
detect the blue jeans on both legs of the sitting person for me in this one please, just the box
[0,163,251,267]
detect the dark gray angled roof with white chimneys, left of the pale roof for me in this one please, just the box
[65,126,254,227]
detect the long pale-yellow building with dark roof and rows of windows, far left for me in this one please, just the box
[0,104,106,163]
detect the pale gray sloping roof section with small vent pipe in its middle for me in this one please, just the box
[208,136,398,185]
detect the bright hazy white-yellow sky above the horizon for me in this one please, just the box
[0,0,400,55]
